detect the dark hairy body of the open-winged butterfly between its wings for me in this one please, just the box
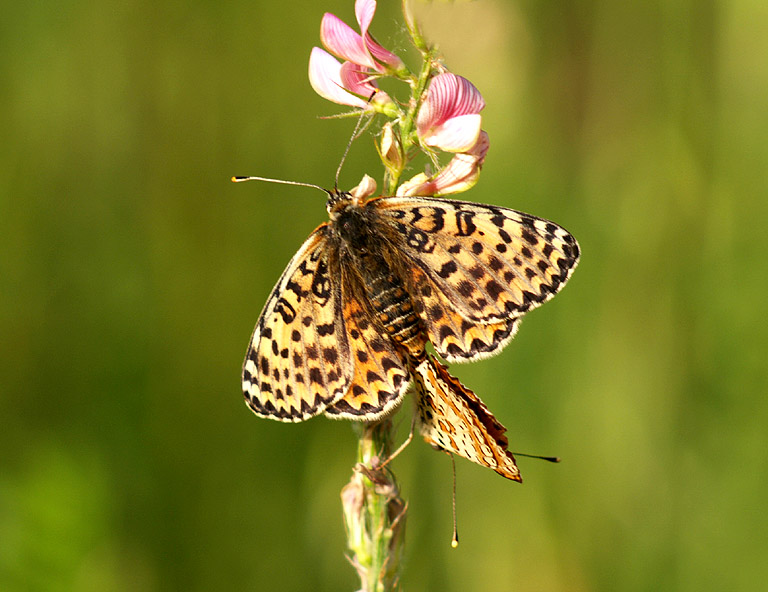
[332,203,426,360]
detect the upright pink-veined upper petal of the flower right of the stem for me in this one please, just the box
[416,72,485,136]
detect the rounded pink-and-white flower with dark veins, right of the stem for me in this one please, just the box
[416,72,485,152]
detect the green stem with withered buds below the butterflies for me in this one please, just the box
[341,419,407,592]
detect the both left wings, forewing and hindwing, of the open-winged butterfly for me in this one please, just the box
[243,224,409,422]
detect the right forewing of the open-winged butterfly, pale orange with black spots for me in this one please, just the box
[366,197,579,323]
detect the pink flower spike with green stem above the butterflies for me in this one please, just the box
[309,0,488,196]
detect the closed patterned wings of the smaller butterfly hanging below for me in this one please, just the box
[413,355,522,481]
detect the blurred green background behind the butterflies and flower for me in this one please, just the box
[0,0,768,592]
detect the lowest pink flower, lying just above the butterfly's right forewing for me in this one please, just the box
[397,131,490,197]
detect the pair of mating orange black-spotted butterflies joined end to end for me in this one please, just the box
[242,190,579,481]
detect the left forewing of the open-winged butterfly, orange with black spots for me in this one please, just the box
[243,224,353,422]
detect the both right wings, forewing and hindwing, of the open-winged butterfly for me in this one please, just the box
[365,197,579,361]
